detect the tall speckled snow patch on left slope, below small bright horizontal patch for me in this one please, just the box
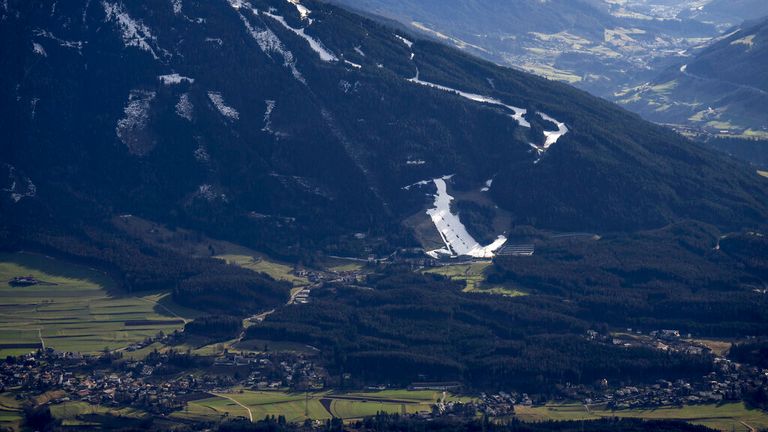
[115,90,157,156]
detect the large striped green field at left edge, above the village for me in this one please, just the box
[0,253,201,356]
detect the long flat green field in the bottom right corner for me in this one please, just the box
[515,403,768,432]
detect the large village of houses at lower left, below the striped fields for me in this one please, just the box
[0,349,327,414]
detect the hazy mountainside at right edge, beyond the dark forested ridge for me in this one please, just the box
[618,18,768,140]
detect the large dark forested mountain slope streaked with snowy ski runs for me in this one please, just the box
[0,0,768,256]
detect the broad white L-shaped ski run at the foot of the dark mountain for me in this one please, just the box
[427,177,507,258]
